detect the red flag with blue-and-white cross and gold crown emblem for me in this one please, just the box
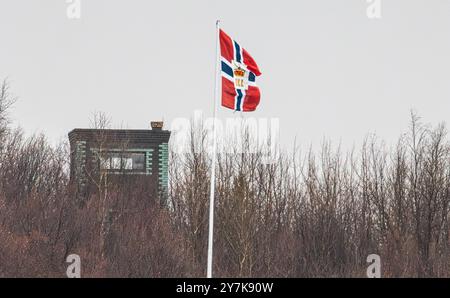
[220,30,261,112]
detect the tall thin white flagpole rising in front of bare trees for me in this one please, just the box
[206,20,220,278]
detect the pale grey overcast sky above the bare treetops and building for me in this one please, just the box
[0,0,450,151]
